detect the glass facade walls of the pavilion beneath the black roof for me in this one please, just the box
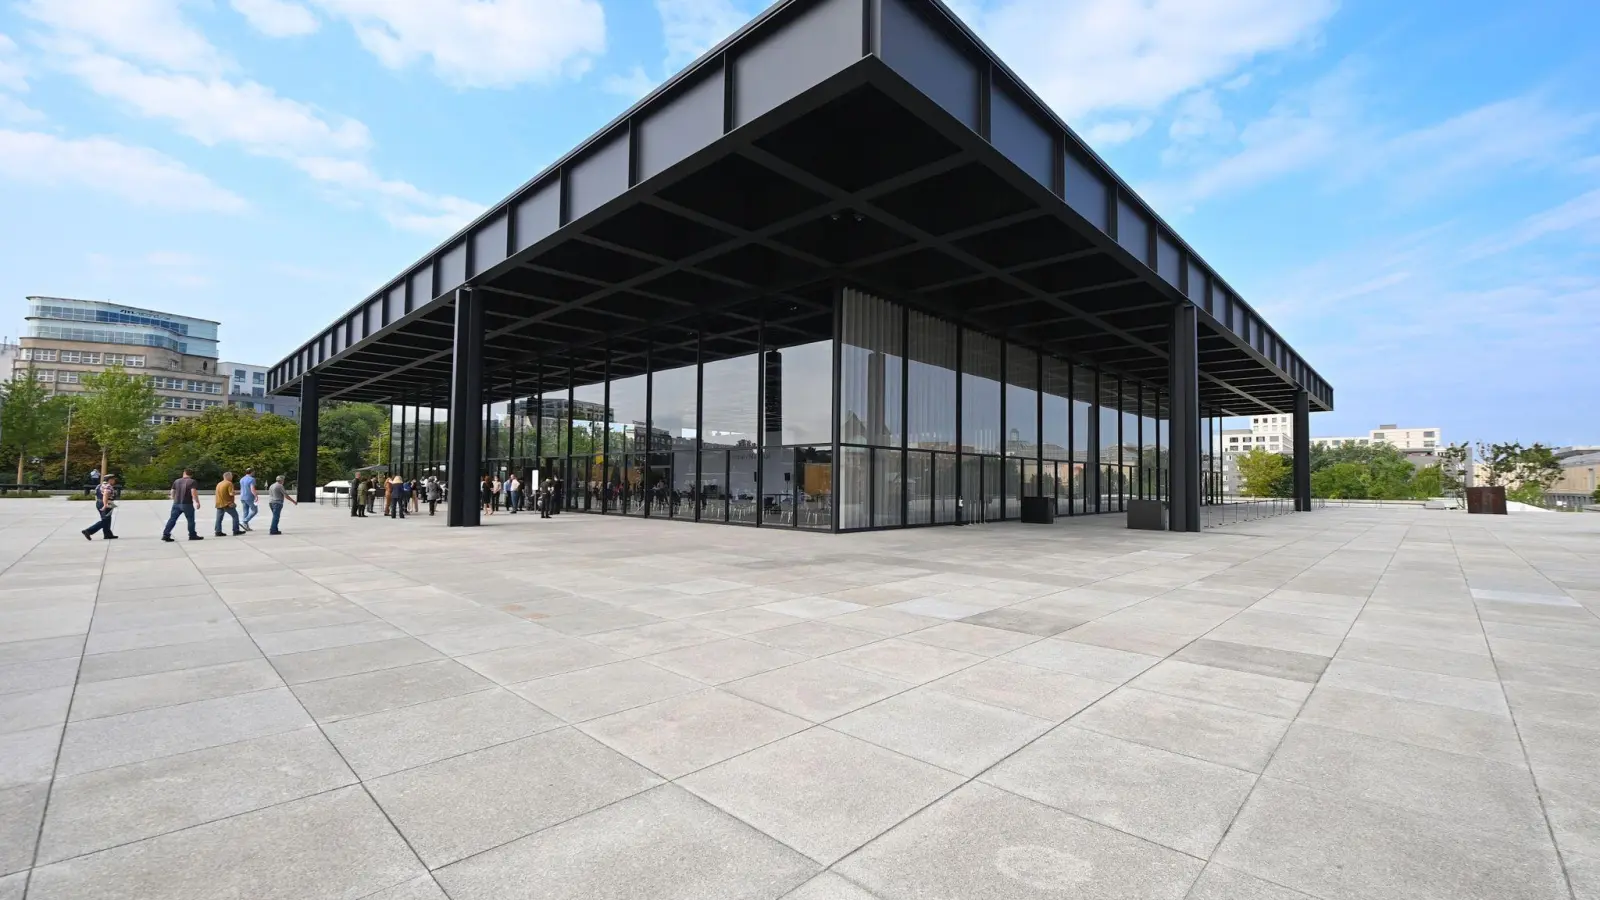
[441,288,1219,532]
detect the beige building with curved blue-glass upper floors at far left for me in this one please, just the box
[11,296,226,424]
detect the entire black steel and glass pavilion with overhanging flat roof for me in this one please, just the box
[267,0,1333,532]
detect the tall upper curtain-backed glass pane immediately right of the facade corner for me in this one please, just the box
[838,288,904,447]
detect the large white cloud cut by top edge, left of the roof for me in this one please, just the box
[315,0,605,88]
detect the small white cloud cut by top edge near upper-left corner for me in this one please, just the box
[21,0,227,72]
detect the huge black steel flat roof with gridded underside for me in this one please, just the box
[269,0,1333,415]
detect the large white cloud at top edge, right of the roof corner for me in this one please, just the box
[966,0,1336,122]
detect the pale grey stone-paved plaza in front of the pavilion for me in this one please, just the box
[0,501,1600,900]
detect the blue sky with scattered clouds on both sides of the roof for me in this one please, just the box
[0,0,1600,444]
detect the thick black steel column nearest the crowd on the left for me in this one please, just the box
[446,287,483,525]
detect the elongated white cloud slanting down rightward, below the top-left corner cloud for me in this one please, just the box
[66,53,371,157]
